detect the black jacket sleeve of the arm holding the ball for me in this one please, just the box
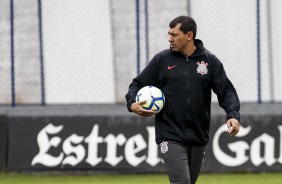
[125,56,158,112]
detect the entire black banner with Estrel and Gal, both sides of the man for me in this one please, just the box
[4,115,282,173]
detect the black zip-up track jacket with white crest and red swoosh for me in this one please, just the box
[125,39,240,146]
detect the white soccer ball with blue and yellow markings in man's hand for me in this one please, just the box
[135,86,165,114]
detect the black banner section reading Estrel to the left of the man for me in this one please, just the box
[8,116,161,172]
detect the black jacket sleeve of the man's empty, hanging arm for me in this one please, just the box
[212,55,240,121]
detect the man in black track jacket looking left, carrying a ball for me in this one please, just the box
[126,16,240,184]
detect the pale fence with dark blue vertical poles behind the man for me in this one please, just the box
[0,0,282,106]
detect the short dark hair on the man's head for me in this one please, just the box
[169,16,197,39]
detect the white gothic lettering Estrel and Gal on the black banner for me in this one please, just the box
[31,123,282,167]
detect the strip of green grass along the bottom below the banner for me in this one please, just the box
[0,173,282,184]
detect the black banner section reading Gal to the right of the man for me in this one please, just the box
[203,115,282,172]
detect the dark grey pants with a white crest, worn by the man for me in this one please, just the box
[159,141,205,184]
